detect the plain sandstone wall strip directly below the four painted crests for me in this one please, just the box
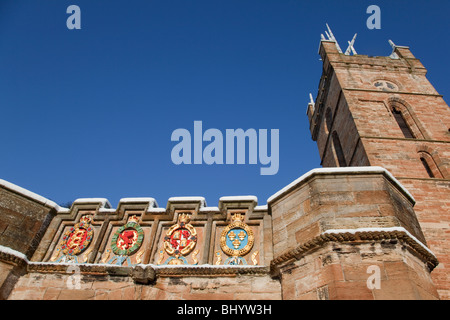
[9,265,281,300]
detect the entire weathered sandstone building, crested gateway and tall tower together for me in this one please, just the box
[0,35,450,300]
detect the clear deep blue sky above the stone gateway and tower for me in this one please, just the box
[0,0,450,207]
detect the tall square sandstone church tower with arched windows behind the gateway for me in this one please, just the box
[307,32,450,299]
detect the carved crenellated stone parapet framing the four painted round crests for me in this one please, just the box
[32,197,272,266]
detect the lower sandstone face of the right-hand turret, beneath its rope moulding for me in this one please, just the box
[280,239,439,300]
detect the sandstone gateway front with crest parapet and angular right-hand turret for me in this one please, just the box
[0,167,438,300]
